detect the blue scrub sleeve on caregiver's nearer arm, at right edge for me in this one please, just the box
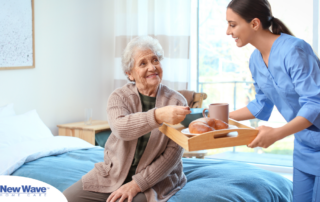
[285,48,320,129]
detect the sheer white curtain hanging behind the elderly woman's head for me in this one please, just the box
[114,0,191,90]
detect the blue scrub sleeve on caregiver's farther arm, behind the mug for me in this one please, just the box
[247,77,274,121]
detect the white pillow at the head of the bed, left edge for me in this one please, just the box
[0,110,53,148]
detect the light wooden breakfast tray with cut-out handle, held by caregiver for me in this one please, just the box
[159,119,258,151]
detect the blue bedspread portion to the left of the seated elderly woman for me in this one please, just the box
[11,147,103,192]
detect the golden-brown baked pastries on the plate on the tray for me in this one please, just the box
[189,117,229,134]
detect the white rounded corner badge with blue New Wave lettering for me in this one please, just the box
[0,176,67,202]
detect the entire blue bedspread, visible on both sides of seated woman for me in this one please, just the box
[12,147,292,202]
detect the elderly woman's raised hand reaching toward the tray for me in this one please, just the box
[155,106,191,124]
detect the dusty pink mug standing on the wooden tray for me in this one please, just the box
[202,103,229,123]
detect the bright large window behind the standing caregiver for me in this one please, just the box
[197,0,319,166]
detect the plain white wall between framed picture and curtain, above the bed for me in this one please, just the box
[0,0,114,135]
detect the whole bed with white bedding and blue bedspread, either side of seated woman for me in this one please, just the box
[0,105,292,202]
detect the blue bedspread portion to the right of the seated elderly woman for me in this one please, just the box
[169,159,292,202]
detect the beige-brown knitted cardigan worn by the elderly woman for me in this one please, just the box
[82,83,187,202]
